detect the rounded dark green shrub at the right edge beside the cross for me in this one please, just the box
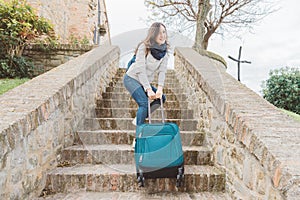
[262,67,300,114]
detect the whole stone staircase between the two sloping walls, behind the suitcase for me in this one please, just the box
[38,69,229,199]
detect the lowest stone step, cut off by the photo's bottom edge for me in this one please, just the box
[33,191,231,200]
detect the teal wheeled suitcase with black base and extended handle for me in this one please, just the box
[134,98,184,187]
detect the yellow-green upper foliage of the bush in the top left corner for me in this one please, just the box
[0,0,53,56]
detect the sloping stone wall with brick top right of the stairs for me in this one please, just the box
[175,48,300,200]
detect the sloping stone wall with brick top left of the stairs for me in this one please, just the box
[0,46,120,199]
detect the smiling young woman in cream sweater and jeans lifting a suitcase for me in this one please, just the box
[123,22,169,126]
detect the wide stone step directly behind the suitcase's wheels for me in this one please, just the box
[45,164,225,193]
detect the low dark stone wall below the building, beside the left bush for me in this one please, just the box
[23,44,94,75]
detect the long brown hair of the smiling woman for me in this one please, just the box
[134,22,169,55]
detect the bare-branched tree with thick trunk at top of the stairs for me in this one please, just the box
[145,0,275,50]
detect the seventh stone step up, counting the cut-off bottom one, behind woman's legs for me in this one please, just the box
[96,98,188,109]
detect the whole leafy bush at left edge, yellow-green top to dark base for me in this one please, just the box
[0,0,55,77]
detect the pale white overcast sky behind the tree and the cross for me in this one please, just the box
[106,0,300,93]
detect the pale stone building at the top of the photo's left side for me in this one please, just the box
[20,0,110,44]
